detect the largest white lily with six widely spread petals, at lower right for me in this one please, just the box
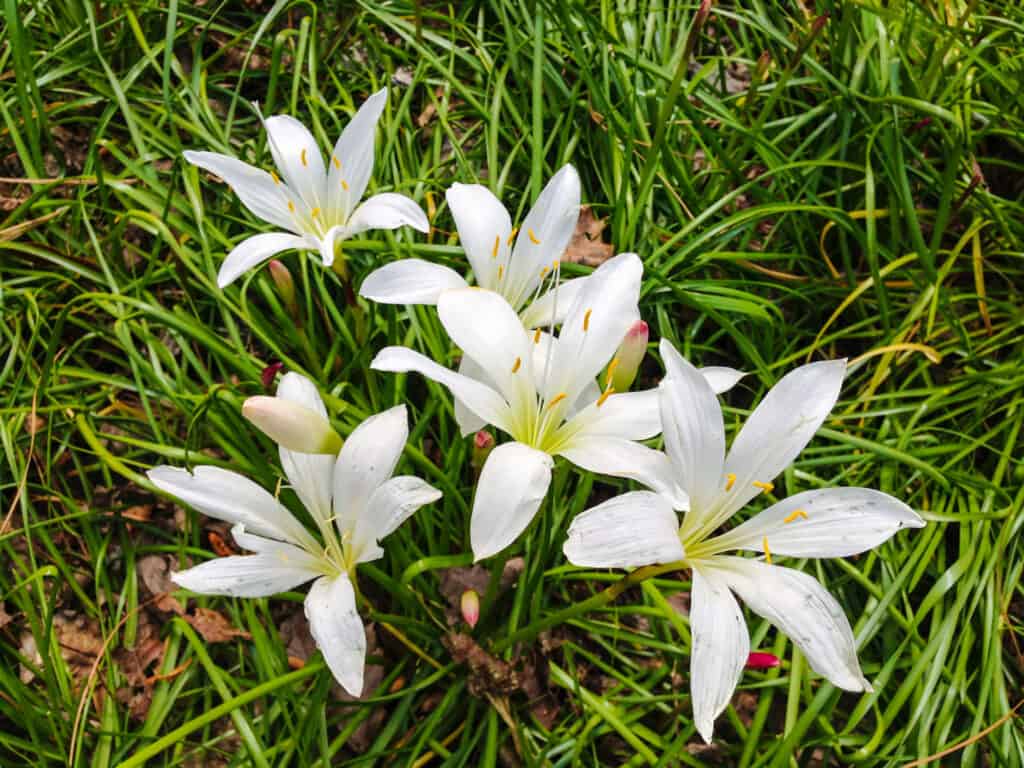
[564,340,925,742]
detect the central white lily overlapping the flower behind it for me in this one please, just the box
[371,254,733,560]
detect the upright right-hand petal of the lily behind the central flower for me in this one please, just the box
[505,165,581,309]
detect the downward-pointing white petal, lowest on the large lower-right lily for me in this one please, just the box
[690,565,751,743]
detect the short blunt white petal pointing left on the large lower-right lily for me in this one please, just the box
[562,490,685,568]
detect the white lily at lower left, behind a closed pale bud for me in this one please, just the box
[147,373,441,696]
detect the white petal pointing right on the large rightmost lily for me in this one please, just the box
[717,488,925,557]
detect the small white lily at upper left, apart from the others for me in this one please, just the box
[184,89,430,288]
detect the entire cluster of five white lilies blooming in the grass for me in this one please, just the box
[150,91,924,741]
